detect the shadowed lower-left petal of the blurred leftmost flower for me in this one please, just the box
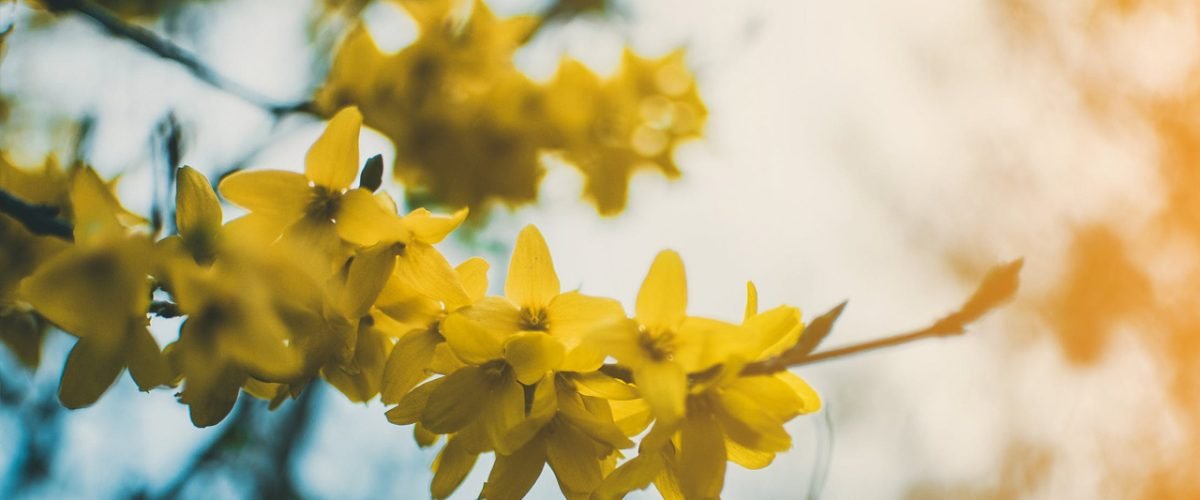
[59,338,124,410]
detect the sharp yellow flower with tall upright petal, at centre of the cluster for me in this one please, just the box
[443,225,624,385]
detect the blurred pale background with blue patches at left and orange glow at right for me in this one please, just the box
[0,0,1200,499]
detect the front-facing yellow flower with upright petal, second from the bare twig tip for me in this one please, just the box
[594,251,745,426]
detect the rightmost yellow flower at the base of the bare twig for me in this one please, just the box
[596,283,821,499]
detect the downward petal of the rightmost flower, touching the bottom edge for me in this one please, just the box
[678,411,726,499]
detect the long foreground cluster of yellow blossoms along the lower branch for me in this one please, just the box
[0,108,821,499]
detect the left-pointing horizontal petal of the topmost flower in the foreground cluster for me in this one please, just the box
[218,170,313,220]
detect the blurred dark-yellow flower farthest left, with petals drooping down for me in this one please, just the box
[19,168,172,408]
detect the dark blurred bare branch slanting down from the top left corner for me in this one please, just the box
[46,0,314,116]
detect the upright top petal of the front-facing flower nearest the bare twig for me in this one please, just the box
[636,251,688,332]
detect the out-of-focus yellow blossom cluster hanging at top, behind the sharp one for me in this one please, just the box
[316,0,707,215]
